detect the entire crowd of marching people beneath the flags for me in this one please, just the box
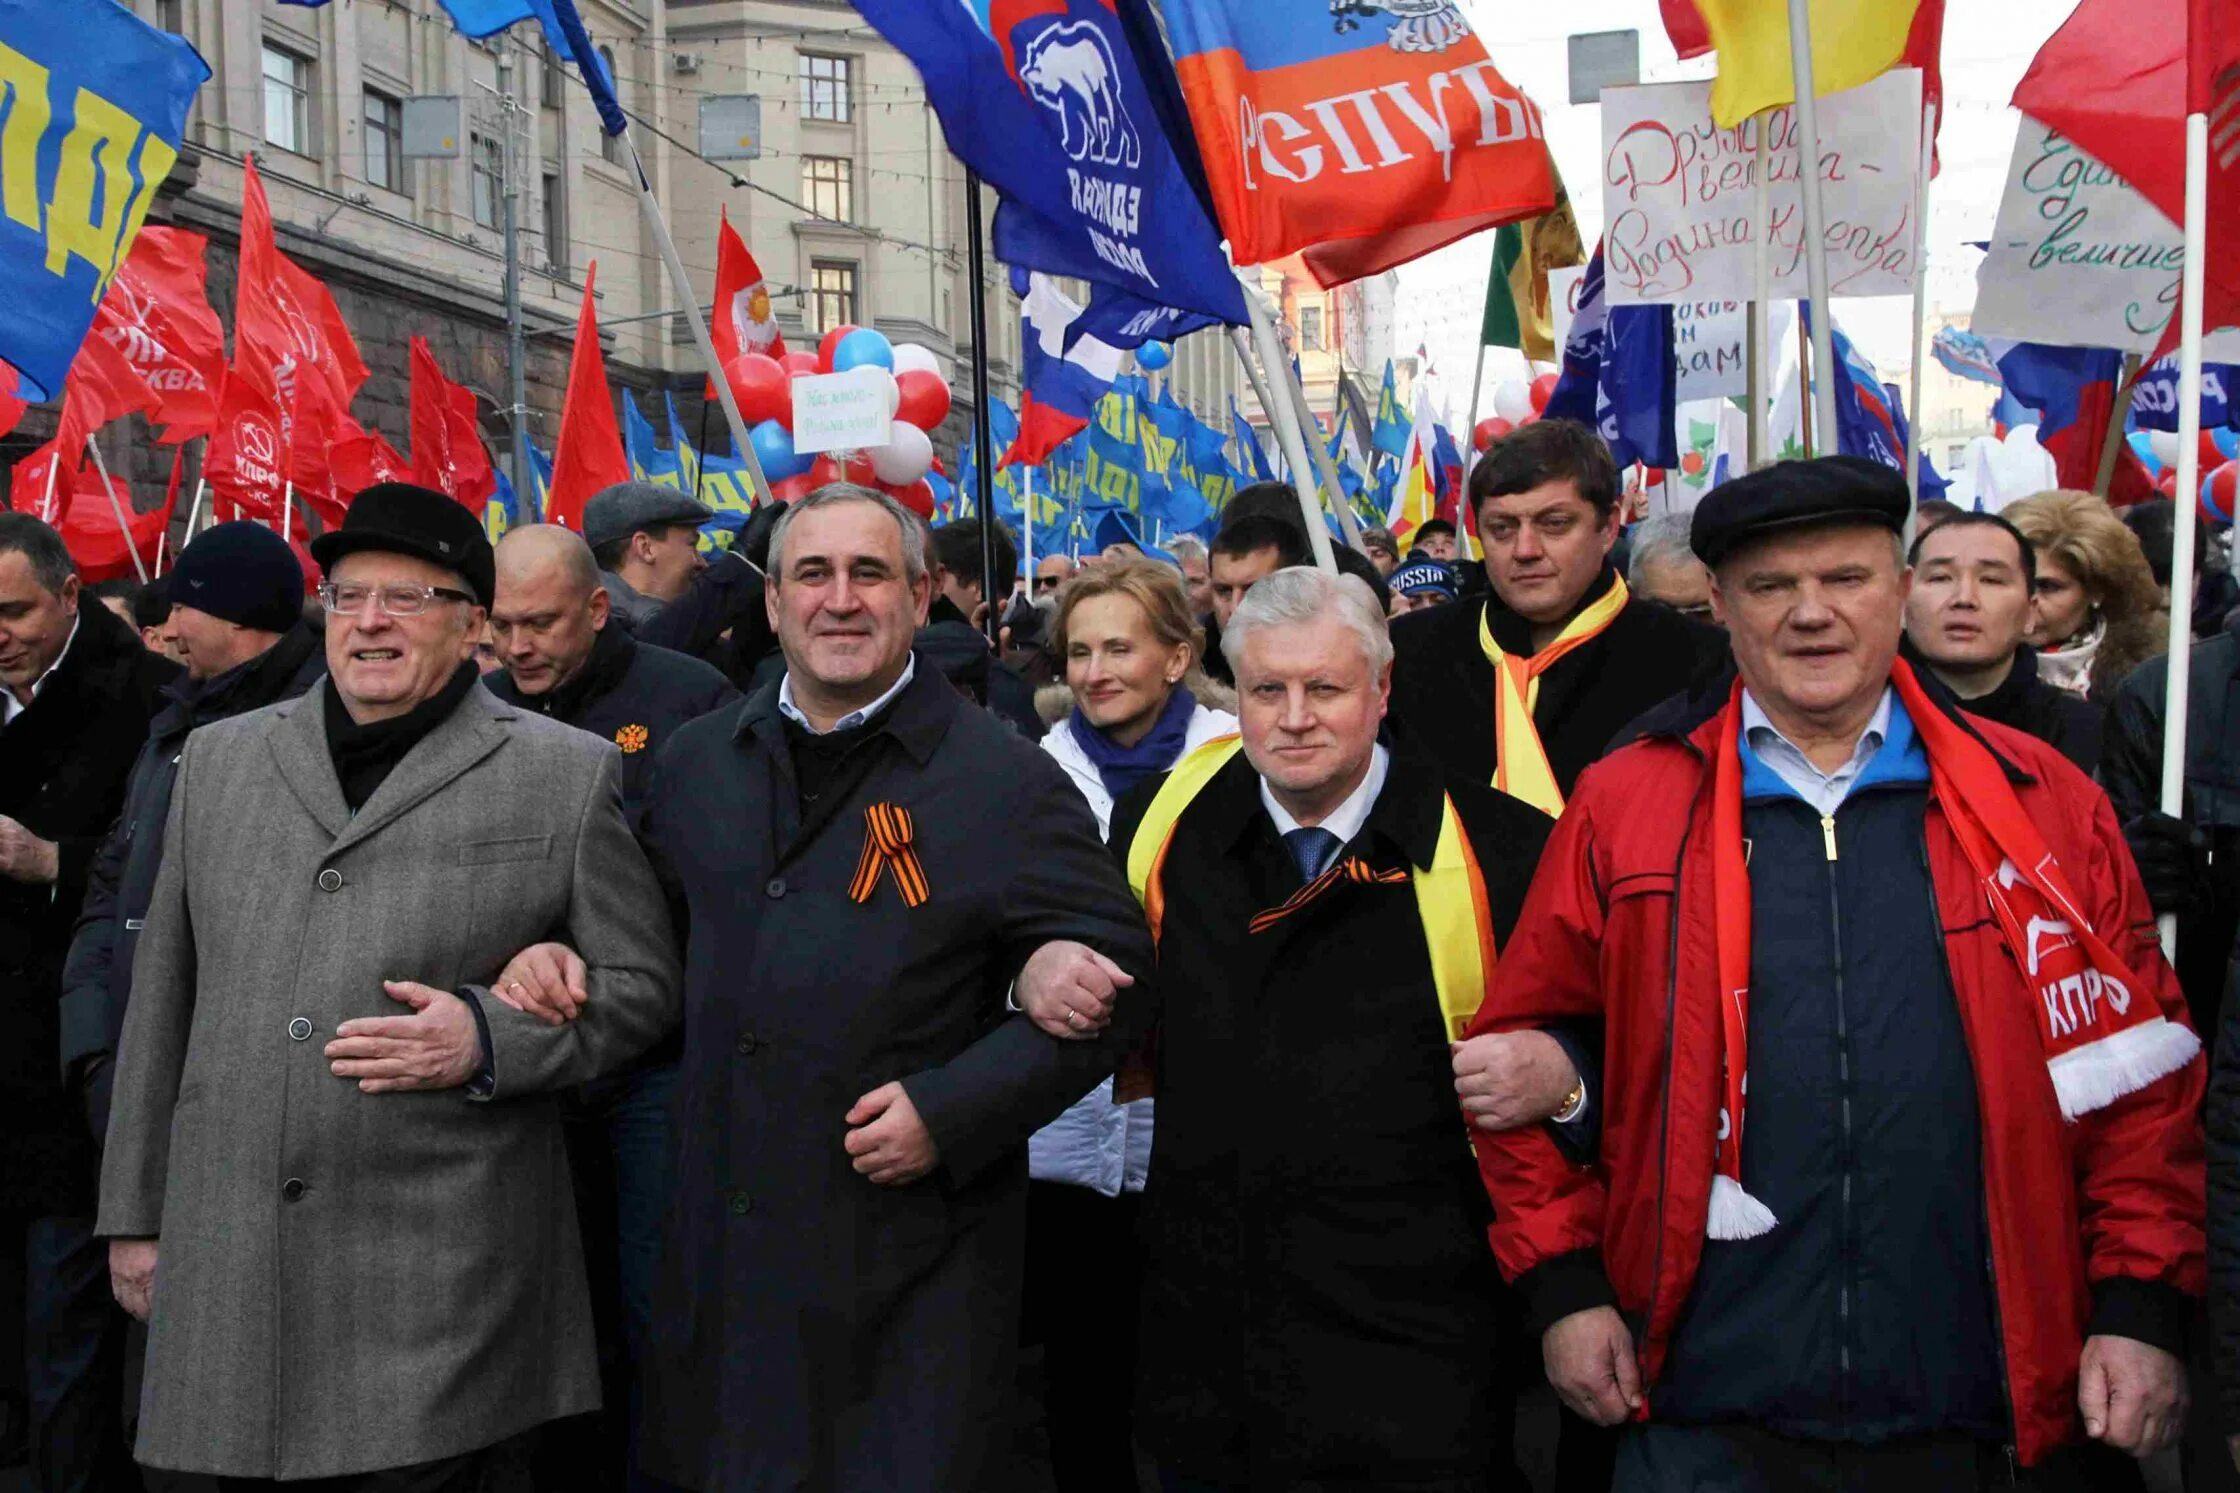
[0,411,2240,1493]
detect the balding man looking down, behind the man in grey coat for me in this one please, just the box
[484,524,739,1489]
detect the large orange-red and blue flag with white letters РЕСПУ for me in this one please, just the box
[1164,0,1555,287]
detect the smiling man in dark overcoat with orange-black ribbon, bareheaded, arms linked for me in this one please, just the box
[506,483,1155,1493]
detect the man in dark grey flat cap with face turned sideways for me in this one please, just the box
[582,481,777,689]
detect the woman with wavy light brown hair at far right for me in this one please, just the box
[2000,490,2166,701]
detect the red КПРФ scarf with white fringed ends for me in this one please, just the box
[1705,660,2202,1240]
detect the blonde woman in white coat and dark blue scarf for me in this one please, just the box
[1026,560,1236,1493]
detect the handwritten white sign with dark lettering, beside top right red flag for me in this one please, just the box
[1971,116,2231,354]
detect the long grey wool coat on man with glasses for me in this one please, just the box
[99,687,681,1480]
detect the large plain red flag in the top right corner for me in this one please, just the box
[2014,0,2240,351]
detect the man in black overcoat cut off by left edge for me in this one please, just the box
[0,513,179,1493]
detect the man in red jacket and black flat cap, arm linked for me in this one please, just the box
[1474,457,2204,1493]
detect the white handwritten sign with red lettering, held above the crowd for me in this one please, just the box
[1602,67,1922,307]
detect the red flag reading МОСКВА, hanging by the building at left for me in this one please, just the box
[94,226,226,443]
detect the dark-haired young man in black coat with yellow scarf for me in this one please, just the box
[1393,421,1725,815]
